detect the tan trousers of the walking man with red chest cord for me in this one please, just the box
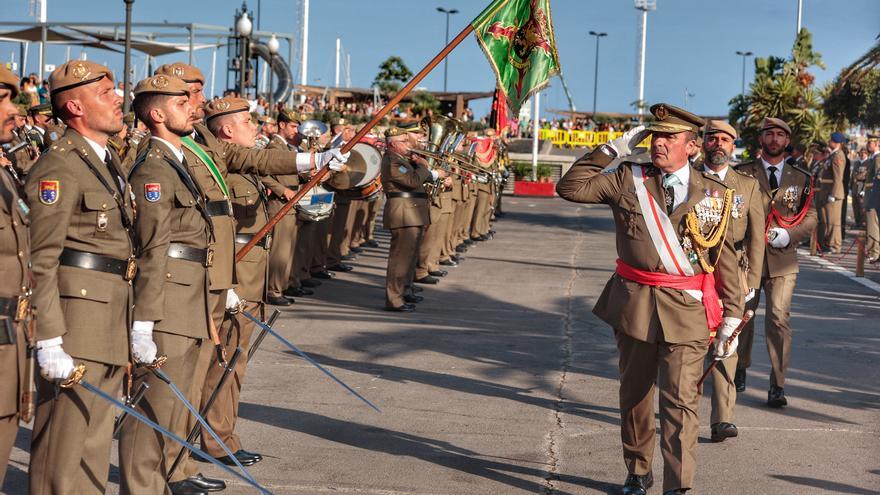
[737,273,797,387]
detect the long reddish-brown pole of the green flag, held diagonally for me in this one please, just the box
[235,8,488,262]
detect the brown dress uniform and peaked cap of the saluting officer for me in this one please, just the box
[556,104,743,493]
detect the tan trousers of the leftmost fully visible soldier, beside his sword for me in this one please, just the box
[28,359,125,495]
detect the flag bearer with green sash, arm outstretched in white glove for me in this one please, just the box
[150,63,347,489]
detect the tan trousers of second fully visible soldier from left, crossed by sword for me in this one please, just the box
[119,331,213,495]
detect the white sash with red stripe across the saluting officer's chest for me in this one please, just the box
[632,165,703,301]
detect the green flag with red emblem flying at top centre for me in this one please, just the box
[473,0,559,115]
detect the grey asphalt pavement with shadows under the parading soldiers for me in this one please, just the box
[5,198,880,495]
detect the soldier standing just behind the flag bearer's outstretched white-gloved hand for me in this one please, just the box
[262,110,305,306]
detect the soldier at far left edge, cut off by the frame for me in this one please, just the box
[0,66,31,487]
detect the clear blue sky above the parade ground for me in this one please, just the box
[0,0,880,117]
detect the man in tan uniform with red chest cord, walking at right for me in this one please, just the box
[734,117,816,407]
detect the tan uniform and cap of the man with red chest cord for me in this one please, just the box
[736,118,816,405]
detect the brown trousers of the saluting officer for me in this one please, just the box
[614,330,706,492]
